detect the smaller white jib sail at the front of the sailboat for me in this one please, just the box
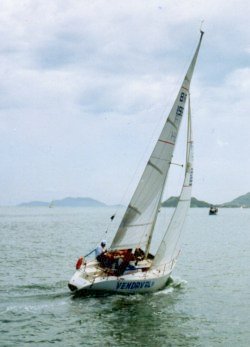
[153,94,193,267]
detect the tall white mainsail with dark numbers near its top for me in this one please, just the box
[110,32,203,252]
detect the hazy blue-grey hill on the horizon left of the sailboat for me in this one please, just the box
[18,198,107,207]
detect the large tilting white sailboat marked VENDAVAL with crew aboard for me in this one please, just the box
[68,31,204,294]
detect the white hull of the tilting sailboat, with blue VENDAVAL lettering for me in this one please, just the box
[69,262,172,294]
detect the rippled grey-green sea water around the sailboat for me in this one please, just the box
[0,207,250,347]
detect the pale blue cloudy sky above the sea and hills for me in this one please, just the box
[0,0,250,205]
